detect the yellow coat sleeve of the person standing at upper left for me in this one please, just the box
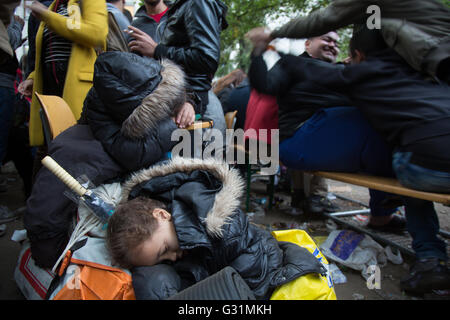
[42,0,108,48]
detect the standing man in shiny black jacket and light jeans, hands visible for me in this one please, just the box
[129,0,228,131]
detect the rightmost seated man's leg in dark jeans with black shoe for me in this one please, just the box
[392,152,450,294]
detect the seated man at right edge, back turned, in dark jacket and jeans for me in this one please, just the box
[282,25,450,293]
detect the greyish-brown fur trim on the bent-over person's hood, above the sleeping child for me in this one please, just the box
[121,59,186,139]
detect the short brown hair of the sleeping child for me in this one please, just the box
[106,197,167,269]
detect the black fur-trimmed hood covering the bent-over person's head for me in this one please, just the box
[93,51,186,139]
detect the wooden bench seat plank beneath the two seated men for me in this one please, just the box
[311,171,450,204]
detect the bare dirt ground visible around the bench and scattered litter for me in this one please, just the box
[0,163,450,300]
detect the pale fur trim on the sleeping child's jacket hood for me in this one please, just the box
[122,157,245,237]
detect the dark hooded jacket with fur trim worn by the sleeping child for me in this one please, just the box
[122,158,326,298]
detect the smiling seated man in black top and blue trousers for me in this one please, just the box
[249,31,405,231]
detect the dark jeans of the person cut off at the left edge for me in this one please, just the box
[0,87,15,166]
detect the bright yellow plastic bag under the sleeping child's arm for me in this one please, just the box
[270,229,337,300]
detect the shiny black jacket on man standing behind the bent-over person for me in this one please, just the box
[155,0,228,105]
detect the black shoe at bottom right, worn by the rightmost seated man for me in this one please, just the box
[400,258,450,295]
